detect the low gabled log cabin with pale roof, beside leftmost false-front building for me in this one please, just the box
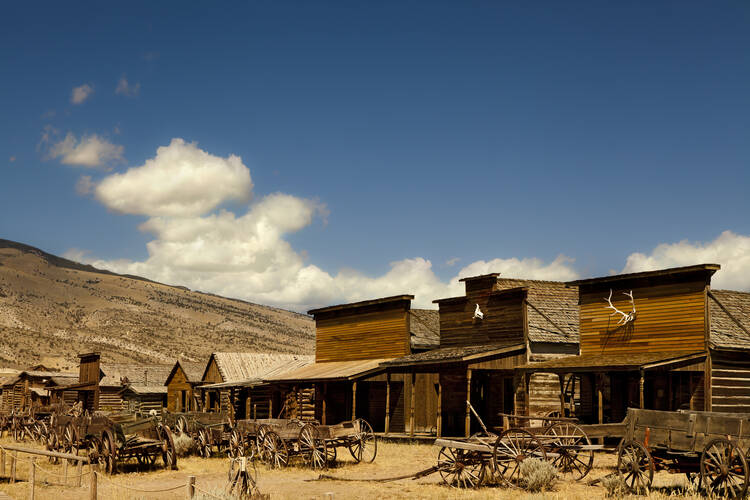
[196,352,313,419]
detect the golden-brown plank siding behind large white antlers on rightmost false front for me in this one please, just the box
[580,281,706,354]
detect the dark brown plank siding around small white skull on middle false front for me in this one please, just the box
[440,291,524,347]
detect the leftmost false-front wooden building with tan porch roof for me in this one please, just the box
[266,295,438,432]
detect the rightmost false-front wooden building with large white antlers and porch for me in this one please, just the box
[518,264,750,423]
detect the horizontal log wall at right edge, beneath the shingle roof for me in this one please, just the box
[711,352,750,413]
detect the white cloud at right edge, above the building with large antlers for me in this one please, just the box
[622,231,750,290]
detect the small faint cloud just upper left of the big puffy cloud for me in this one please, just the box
[49,130,125,167]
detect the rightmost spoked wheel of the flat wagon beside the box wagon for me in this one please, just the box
[544,422,594,481]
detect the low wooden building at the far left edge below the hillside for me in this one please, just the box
[2,370,75,412]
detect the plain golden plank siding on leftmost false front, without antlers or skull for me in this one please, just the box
[315,305,410,362]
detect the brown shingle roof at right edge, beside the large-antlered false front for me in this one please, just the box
[708,290,750,349]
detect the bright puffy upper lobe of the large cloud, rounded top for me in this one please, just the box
[96,139,253,217]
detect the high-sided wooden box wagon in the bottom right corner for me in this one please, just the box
[617,408,750,498]
